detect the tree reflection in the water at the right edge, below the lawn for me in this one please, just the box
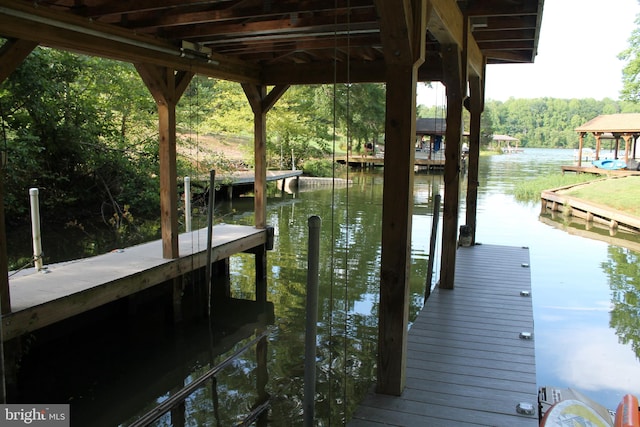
[602,246,640,359]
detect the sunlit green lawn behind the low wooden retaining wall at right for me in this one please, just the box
[560,176,640,217]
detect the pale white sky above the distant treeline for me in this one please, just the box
[418,0,640,105]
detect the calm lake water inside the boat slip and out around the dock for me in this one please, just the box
[8,149,640,426]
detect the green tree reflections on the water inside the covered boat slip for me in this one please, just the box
[224,173,440,425]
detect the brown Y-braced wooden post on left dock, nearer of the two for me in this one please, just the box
[136,64,194,258]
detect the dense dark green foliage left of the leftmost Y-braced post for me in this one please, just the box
[0,48,159,224]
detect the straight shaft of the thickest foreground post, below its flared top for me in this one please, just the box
[377,61,417,395]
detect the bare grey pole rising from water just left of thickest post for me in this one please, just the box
[303,215,322,427]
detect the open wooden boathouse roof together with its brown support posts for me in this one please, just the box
[0,0,544,422]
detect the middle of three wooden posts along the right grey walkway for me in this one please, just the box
[440,45,466,289]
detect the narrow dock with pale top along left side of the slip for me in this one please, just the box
[2,224,268,341]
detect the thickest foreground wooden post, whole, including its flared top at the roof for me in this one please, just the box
[374,0,427,395]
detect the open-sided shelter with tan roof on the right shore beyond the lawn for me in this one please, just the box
[575,113,640,166]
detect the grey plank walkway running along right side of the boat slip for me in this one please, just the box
[349,245,538,427]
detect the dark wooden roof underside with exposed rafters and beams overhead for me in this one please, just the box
[0,0,543,84]
